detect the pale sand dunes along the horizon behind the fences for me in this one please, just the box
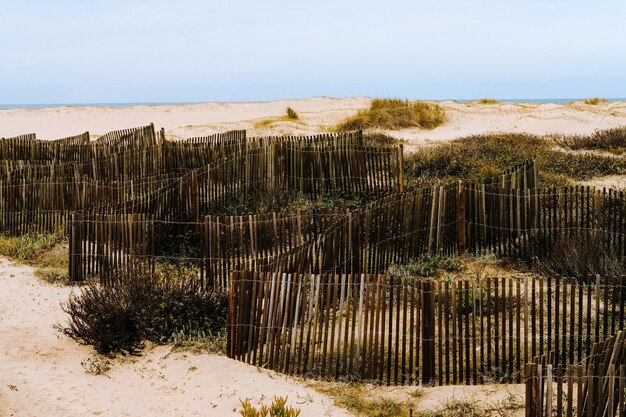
[0,97,626,145]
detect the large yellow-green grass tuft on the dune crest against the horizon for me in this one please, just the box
[335,99,446,132]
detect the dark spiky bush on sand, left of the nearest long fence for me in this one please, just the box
[63,268,228,354]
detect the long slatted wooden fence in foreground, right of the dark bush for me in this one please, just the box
[228,271,626,385]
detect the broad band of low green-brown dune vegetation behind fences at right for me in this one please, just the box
[404,133,626,186]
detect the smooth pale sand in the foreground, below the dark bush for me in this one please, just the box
[0,260,349,417]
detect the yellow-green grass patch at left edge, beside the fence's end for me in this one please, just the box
[0,233,69,283]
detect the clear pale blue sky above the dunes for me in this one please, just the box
[0,0,626,104]
